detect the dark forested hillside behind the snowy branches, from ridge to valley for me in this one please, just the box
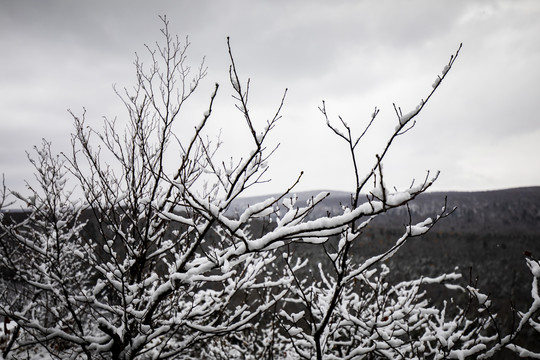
[4,187,540,358]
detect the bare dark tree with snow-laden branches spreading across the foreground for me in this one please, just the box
[0,17,540,359]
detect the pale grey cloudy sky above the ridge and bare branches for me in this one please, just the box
[0,0,540,194]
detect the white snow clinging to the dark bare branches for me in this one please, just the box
[0,63,540,359]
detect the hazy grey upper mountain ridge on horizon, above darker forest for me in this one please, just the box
[232,186,540,234]
